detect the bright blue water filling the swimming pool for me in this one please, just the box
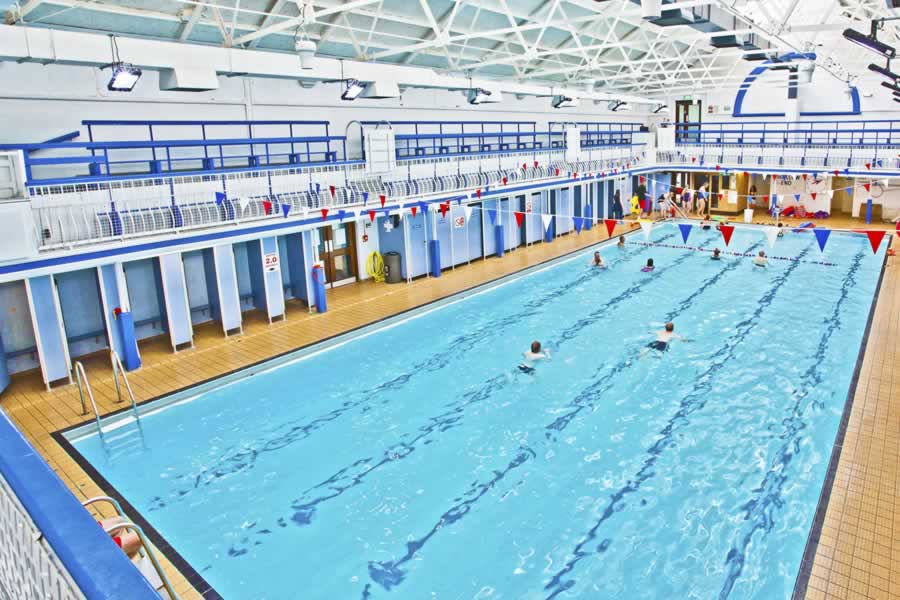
[74,226,884,600]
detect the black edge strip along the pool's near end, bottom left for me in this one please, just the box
[51,426,224,600]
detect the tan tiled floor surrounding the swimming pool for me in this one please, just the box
[0,217,900,599]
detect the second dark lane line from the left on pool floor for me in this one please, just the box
[221,231,721,556]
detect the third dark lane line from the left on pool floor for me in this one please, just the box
[346,237,759,600]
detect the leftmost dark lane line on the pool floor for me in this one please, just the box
[148,234,674,512]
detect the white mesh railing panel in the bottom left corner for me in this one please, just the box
[0,475,84,600]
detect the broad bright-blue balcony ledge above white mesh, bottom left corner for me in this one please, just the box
[0,410,159,600]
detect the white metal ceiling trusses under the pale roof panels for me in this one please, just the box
[7,0,900,98]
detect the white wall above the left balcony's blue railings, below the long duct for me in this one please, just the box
[0,62,645,143]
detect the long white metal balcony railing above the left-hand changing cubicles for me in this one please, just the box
[30,146,644,250]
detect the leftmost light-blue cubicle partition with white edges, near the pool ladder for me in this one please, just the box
[25,275,72,389]
